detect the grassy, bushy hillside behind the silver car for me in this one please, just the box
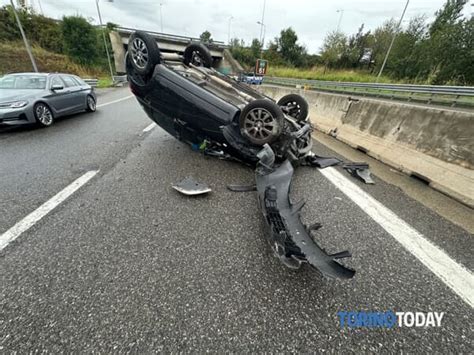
[0,5,115,84]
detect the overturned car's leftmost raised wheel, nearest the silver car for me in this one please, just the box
[128,31,161,76]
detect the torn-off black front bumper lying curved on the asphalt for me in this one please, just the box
[256,147,355,279]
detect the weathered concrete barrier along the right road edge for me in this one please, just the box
[260,85,474,208]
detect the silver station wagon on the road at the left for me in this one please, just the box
[0,73,97,127]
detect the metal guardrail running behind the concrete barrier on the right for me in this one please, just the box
[264,76,474,107]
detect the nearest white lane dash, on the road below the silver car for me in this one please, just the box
[0,170,99,250]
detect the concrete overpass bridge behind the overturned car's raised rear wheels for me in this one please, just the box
[110,27,243,74]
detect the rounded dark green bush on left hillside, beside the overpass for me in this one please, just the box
[61,16,99,65]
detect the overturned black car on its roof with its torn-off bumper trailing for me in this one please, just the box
[126,32,355,278]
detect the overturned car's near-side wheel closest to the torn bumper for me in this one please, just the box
[239,99,285,145]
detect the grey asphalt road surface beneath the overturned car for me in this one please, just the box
[0,88,474,353]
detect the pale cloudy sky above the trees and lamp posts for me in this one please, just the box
[0,0,474,53]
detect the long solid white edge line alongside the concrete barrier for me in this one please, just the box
[319,168,474,308]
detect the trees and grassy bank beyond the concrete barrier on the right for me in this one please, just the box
[230,0,474,85]
